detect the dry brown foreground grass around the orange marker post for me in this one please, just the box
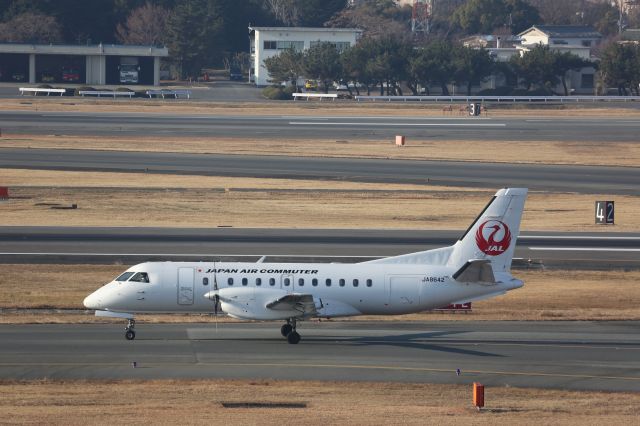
[0,380,640,426]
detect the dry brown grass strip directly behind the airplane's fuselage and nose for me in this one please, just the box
[0,264,640,323]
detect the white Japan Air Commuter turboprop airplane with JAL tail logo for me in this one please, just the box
[84,188,527,344]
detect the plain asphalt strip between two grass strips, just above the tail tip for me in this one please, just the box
[0,148,640,195]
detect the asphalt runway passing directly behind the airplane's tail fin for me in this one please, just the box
[0,227,640,269]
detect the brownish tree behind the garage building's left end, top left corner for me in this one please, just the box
[0,12,62,43]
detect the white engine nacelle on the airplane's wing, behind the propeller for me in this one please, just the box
[204,287,300,320]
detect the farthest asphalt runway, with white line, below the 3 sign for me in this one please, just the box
[0,111,640,143]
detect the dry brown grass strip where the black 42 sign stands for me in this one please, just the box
[0,174,640,232]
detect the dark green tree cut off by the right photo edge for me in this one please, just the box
[599,43,640,95]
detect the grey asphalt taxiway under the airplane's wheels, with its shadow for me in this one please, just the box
[0,321,640,392]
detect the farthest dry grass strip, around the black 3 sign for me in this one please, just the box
[0,97,640,117]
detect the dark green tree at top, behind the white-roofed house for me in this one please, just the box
[451,0,540,34]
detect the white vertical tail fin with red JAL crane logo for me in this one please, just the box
[447,188,527,272]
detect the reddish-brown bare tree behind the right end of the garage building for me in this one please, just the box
[116,1,169,46]
